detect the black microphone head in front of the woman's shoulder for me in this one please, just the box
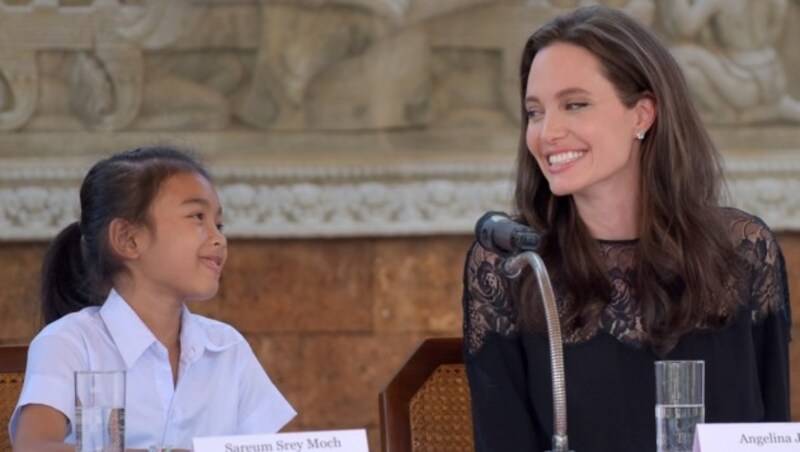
[475,212,542,255]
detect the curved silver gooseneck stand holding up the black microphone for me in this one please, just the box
[502,251,570,452]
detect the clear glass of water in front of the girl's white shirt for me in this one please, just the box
[75,371,125,452]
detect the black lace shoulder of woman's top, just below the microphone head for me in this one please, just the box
[463,243,517,355]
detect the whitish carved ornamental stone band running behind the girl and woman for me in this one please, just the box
[0,155,800,240]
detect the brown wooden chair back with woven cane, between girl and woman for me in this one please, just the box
[379,338,475,452]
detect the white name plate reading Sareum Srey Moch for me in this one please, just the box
[193,429,369,452]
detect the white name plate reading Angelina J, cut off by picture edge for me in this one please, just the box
[693,422,800,452]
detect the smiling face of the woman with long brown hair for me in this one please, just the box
[525,42,654,203]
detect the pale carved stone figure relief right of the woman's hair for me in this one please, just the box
[660,0,800,125]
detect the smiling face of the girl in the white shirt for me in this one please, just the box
[128,172,227,302]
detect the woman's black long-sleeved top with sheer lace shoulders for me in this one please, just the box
[464,209,790,452]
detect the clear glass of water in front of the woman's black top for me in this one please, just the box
[656,361,705,452]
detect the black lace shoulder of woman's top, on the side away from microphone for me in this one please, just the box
[731,209,791,325]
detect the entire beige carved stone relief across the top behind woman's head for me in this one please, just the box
[0,0,800,131]
